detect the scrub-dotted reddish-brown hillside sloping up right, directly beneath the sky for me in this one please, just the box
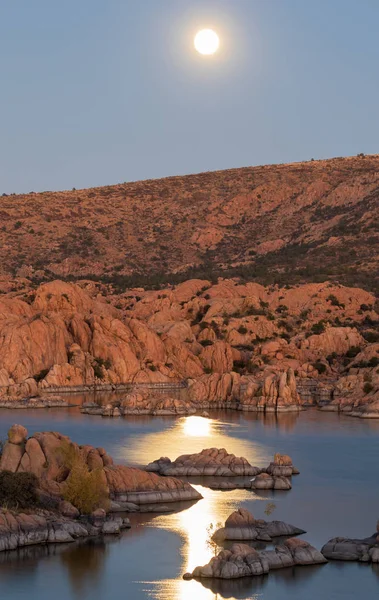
[0,156,379,291]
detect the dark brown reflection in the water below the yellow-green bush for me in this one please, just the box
[61,539,107,598]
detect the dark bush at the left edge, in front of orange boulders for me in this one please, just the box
[0,471,38,509]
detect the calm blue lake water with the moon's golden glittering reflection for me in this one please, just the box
[0,409,379,600]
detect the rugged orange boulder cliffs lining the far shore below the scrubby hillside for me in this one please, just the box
[0,279,379,410]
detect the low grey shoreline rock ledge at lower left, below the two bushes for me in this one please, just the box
[0,510,130,552]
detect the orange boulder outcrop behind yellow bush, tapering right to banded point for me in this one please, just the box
[0,425,201,510]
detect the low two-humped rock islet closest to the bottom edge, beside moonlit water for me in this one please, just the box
[184,538,327,579]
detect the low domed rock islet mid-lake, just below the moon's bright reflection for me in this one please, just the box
[146,448,261,477]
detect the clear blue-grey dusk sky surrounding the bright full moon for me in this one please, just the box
[0,0,379,194]
